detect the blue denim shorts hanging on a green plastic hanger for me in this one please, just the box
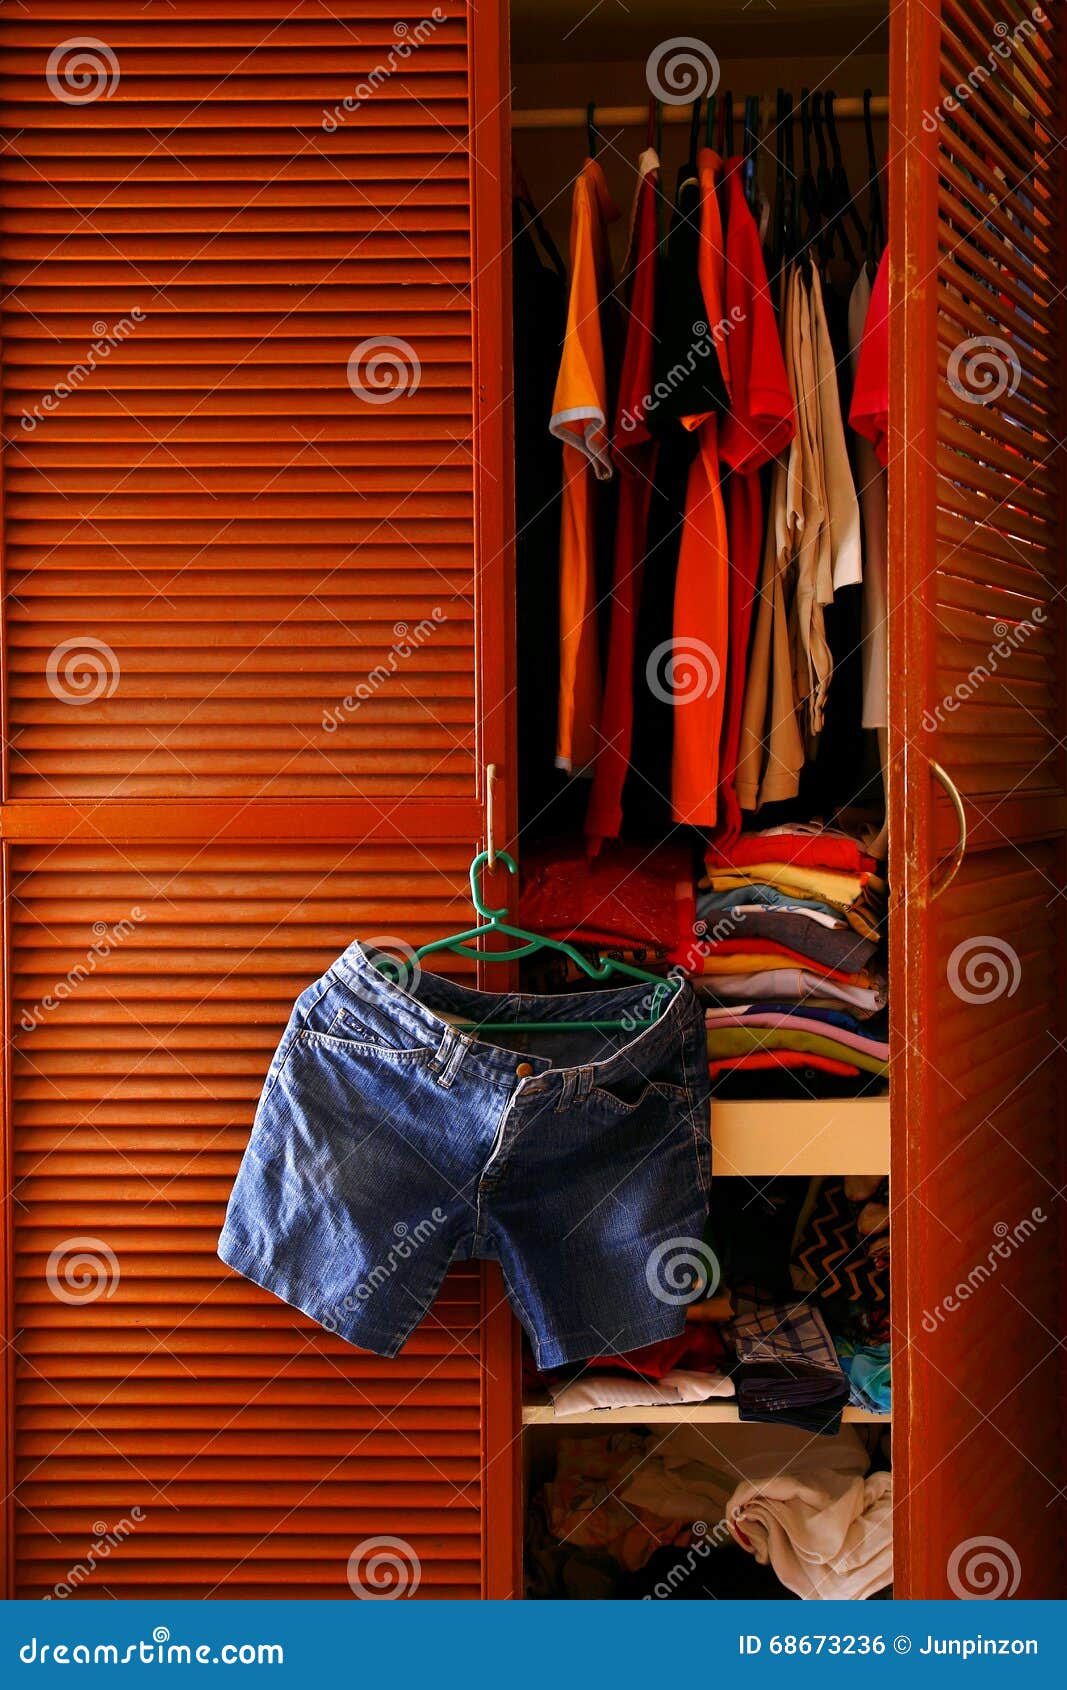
[218,945,714,1367]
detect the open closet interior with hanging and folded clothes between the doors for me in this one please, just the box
[511,0,891,1599]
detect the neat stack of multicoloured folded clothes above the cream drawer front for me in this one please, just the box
[693,823,889,1095]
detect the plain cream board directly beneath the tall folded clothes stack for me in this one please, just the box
[712,1097,889,1180]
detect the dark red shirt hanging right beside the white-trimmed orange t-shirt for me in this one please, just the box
[585,147,659,855]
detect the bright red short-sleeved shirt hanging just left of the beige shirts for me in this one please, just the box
[717,157,795,840]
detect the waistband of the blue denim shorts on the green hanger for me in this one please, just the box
[328,940,705,1100]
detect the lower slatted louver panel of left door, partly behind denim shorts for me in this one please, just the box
[10,847,493,1597]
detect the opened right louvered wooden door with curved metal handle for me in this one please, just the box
[889,0,1067,1597]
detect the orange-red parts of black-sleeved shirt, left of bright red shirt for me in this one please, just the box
[671,147,730,828]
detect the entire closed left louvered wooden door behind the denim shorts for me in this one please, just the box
[0,0,514,1599]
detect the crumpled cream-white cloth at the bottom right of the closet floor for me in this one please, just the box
[725,1466,893,1602]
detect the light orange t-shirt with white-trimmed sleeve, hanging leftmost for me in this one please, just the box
[551,159,619,774]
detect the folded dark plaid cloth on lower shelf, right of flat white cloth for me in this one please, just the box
[732,1300,849,1435]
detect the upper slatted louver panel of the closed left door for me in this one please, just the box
[0,0,475,799]
